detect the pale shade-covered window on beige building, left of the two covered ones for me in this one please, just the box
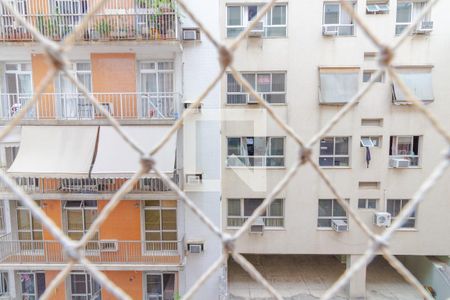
[319,67,359,104]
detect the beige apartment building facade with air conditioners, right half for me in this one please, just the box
[221,0,450,298]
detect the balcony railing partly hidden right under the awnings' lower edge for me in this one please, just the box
[0,175,178,194]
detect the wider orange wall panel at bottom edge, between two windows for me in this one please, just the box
[102,271,143,300]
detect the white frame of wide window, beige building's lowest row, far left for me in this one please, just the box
[227,198,286,230]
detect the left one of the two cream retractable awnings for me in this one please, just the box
[8,126,98,178]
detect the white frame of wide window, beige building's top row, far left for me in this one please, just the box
[225,2,289,39]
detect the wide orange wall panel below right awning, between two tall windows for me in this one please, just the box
[98,200,141,241]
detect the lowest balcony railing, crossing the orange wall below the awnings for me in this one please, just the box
[0,234,184,265]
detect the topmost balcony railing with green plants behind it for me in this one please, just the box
[0,0,180,42]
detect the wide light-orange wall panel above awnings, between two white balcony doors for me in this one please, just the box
[91,53,136,93]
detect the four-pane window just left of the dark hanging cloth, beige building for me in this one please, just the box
[319,137,350,167]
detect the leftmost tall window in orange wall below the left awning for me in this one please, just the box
[16,200,43,251]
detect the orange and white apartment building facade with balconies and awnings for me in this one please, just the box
[0,0,221,299]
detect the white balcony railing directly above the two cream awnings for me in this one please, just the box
[0,93,180,120]
